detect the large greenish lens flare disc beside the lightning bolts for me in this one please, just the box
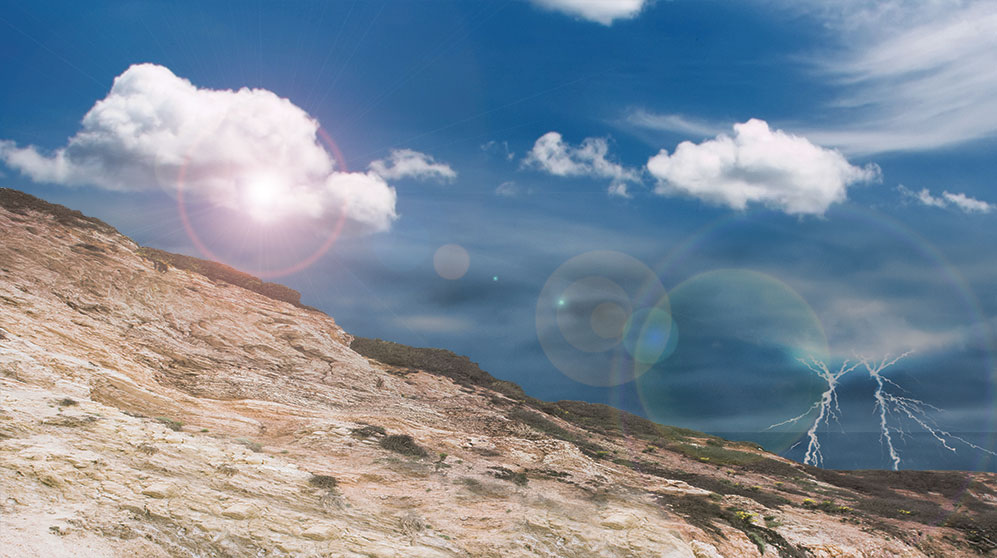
[627,269,828,445]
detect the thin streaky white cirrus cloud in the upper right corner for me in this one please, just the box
[792,0,997,153]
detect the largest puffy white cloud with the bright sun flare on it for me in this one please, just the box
[0,64,397,230]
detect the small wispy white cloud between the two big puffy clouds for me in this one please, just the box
[523,132,641,196]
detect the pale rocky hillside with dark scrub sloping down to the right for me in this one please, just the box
[0,189,997,558]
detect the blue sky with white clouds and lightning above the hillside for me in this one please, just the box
[0,0,997,471]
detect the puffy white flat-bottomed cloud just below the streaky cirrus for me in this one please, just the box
[647,119,880,215]
